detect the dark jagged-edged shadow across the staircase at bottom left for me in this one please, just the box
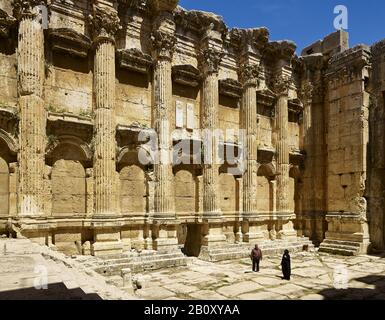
[0,283,102,300]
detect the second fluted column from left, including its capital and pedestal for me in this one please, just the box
[91,1,123,256]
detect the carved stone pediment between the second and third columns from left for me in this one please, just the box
[116,48,153,74]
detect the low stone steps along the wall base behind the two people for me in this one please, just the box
[199,237,314,262]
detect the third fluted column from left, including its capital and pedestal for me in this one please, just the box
[151,10,178,252]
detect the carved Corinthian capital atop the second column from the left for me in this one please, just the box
[90,5,121,41]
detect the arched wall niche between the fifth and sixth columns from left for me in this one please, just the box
[257,163,275,213]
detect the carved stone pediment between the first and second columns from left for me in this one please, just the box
[48,28,91,58]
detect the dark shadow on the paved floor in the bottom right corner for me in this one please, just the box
[318,275,385,300]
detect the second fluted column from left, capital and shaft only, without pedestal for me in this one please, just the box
[93,3,119,216]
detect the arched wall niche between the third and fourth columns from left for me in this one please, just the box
[174,166,199,216]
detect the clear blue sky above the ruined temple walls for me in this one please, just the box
[179,0,385,52]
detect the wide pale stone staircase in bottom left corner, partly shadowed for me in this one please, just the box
[0,239,137,300]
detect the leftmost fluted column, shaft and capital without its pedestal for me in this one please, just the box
[13,1,46,216]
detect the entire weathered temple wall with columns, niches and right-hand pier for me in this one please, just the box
[0,0,385,260]
